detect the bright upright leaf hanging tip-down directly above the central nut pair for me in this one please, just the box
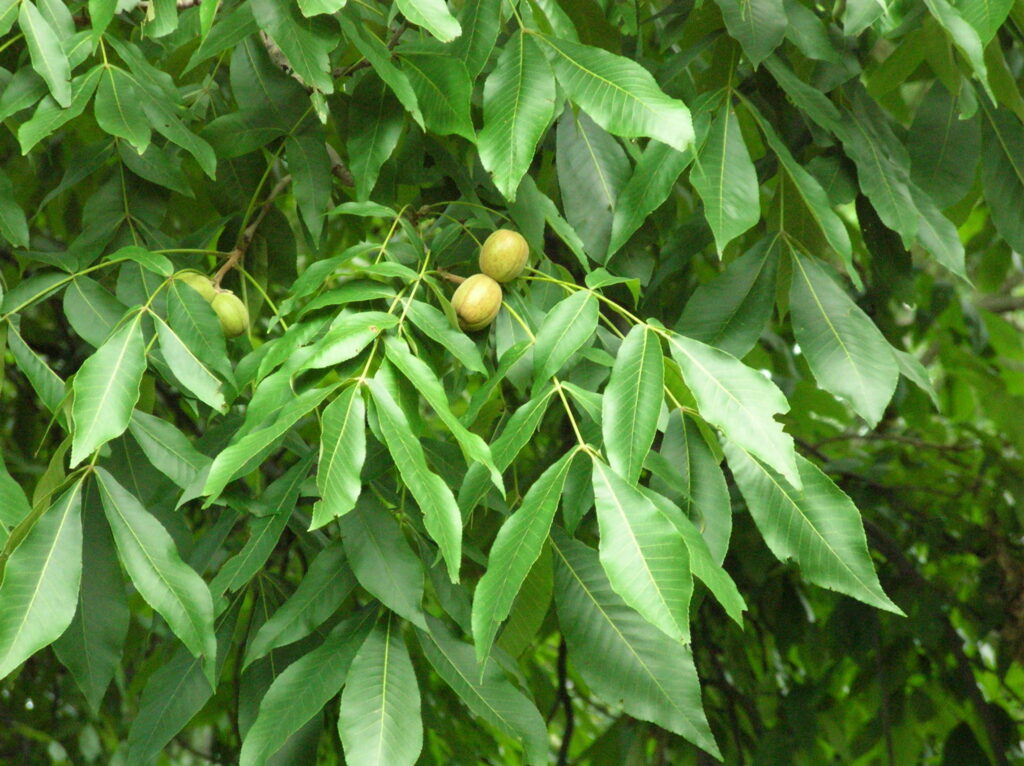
[477,32,555,201]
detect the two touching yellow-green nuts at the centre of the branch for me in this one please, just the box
[452,228,529,332]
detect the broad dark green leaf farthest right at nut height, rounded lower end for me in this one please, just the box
[790,252,899,427]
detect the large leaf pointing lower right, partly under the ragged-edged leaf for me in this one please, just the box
[725,441,903,614]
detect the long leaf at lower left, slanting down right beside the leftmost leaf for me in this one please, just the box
[95,468,217,680]
